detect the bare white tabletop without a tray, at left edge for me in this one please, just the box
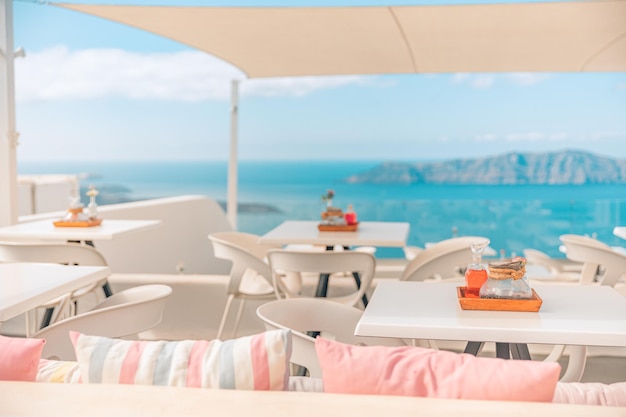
[0,263,111,324]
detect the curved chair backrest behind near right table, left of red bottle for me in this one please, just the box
[400,236,487,281]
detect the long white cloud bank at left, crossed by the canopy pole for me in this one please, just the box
[15,46,384,102]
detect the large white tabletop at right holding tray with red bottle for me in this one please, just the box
[355,281,626,373]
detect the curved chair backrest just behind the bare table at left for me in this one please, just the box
[0,242,107,266]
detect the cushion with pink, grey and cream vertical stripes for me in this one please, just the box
[70,330,291,391]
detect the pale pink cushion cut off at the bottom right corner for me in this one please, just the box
[552,382,626,407]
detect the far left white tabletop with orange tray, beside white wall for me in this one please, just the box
[0,219,161,242]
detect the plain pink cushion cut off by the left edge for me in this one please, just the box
[0,335,46,381]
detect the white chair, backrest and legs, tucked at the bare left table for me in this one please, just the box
[0,242,107,335]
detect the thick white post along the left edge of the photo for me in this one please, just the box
[0,0,18,226]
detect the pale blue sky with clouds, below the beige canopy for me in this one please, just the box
[13,0,626,163]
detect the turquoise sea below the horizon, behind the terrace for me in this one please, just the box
[18,161,626,257]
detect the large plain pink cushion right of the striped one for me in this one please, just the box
[315,337,561,402]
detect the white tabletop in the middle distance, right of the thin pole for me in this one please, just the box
[259,220,409,247]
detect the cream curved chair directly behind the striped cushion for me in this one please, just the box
[32,284,172,360]
